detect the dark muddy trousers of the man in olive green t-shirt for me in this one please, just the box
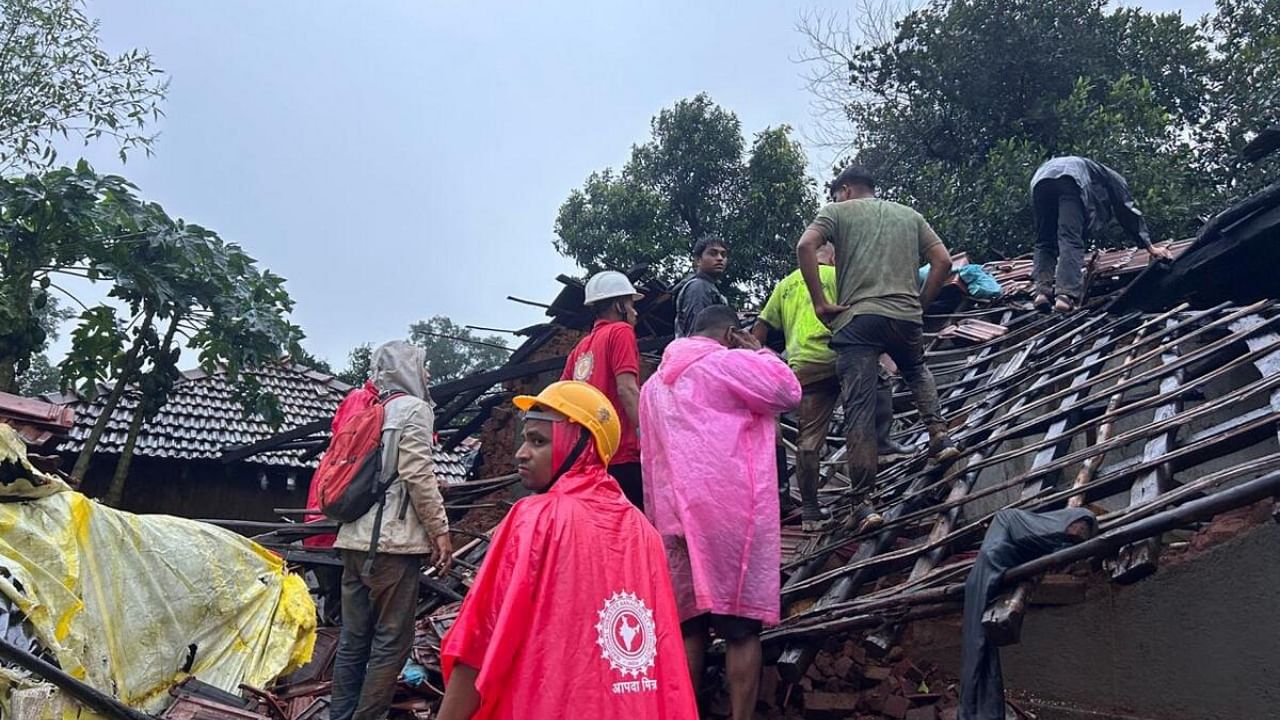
[831,315,946,505]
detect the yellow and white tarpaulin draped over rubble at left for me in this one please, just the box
[0,424,315,712]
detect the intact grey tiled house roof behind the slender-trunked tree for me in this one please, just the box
[58,363,467,482]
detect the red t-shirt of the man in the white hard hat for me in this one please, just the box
[561,320,640,465]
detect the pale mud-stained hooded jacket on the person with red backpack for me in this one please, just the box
[335,341,449,555]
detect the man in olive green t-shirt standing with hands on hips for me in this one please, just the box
[796,165,960,532]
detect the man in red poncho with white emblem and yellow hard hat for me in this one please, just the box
[439,380,698,720]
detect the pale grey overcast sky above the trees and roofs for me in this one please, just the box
[54,0,1212,366]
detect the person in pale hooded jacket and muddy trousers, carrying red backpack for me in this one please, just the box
[329,341,453,720]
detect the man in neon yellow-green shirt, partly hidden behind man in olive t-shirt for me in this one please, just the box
[751,242,911,532]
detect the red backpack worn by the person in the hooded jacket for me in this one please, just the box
[311,392,404,520]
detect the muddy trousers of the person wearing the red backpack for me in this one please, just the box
[329,550,422,720]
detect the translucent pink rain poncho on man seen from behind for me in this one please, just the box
[640,337,800,625]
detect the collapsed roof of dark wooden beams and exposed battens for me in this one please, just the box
[147,169,1280,717]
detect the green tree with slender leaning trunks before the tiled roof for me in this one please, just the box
[60,198,301,497]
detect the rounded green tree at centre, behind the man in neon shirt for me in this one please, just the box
[554,94,817,300]
